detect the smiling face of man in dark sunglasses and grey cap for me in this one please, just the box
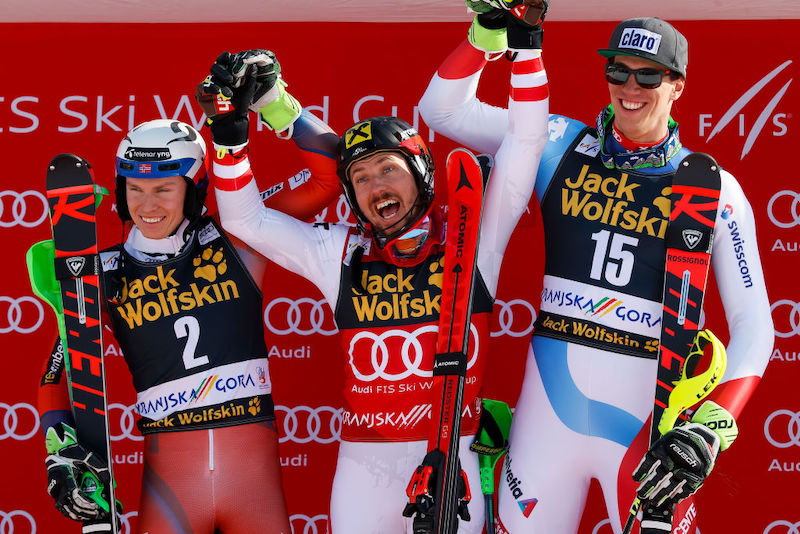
[608,56,686,144]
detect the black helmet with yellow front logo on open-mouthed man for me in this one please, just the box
[337,117,434,239]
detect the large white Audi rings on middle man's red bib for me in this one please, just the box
[347,324,480,382]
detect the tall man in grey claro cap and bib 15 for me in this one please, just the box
[420,8,773,534]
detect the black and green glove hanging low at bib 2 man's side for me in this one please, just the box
[45,423,110,521]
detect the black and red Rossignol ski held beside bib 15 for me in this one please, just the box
[623,152,721,534]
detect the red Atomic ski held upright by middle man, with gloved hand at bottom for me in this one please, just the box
[403,149,491,534]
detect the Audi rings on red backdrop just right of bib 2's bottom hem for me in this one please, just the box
[275,406,342,446]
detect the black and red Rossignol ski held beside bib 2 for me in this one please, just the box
[47,154,117,532]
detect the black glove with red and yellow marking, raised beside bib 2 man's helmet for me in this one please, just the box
[195,52,256,147]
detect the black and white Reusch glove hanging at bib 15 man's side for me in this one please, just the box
[633,423,720,508]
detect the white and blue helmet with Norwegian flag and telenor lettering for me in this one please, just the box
[116,119,208,222]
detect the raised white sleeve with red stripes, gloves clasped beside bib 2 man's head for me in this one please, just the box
[196,49,347,304]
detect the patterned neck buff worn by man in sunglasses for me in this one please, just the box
[597,106,683,170]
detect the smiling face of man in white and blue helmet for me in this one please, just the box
[125,176,186,239]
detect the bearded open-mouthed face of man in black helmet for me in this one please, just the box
[349,152,419,234]
